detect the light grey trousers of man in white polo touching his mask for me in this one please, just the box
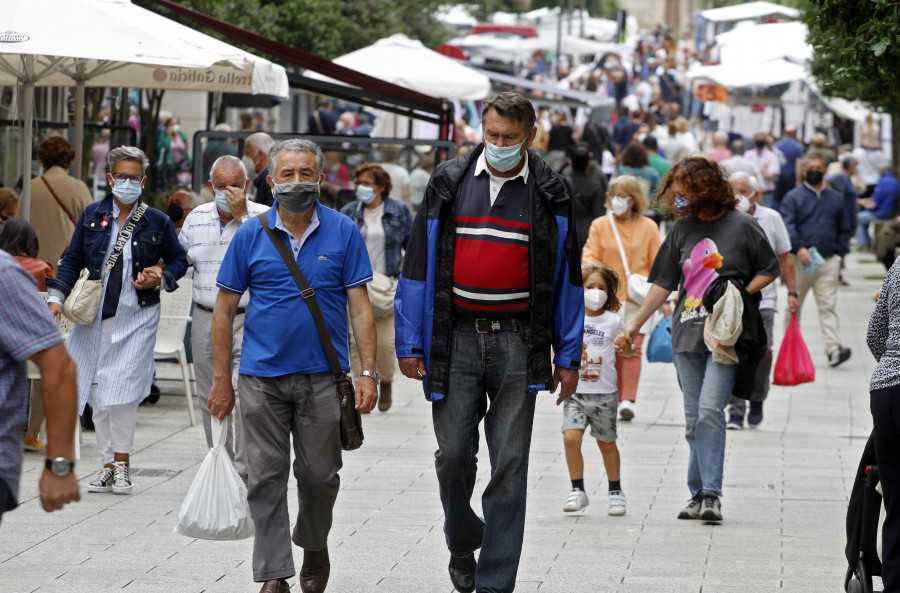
[191,307,247,481]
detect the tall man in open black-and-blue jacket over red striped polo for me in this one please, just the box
[395,92,584,593]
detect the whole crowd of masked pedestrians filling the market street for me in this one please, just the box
[0,77,900,593]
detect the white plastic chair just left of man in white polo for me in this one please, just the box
[153,275,197,426]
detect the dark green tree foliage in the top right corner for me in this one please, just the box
[803,0,900,162]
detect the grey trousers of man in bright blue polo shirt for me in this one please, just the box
[238,373,342,582]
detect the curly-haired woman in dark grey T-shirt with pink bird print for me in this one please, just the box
[617,157,779,521]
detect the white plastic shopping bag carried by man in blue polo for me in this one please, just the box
[175,417,254,540]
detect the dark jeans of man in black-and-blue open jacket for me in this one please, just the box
[432,327,536,593]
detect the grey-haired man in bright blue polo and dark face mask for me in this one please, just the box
[209,140,378,593]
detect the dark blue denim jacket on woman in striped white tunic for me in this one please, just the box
[47,194,188,307]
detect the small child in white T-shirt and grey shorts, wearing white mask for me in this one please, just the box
[562,263,634,516]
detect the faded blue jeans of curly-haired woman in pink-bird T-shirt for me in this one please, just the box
[674,352,737,496]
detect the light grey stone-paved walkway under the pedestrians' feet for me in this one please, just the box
[0,254,884,593]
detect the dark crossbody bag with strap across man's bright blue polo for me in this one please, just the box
[257,212,363,451]
